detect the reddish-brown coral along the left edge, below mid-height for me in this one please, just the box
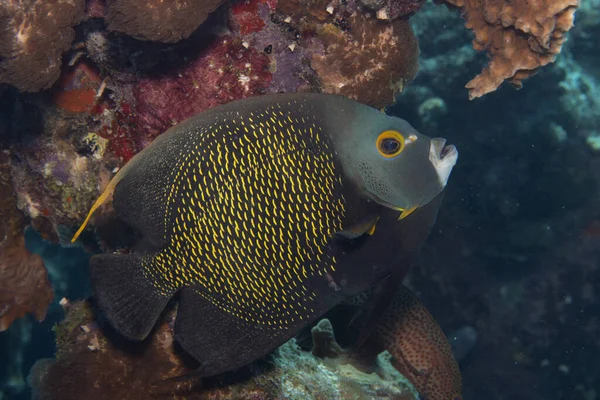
[0,154,53,332]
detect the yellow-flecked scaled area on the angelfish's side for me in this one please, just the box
[143,104,345,328]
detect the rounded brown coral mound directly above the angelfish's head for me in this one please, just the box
[277,0,419,108]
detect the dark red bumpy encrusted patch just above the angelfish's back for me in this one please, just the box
[132,36,271,142]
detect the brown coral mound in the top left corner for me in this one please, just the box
[0,0,85,92]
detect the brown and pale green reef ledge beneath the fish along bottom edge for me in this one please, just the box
[29,301,416,400]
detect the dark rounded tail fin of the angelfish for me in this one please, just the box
[90,254,171,340]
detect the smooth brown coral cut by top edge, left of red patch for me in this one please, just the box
[105,0,223,43]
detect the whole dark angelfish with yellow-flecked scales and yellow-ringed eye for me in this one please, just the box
[73,93,457,376]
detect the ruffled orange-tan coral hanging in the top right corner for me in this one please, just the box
[438,0,579,99]
